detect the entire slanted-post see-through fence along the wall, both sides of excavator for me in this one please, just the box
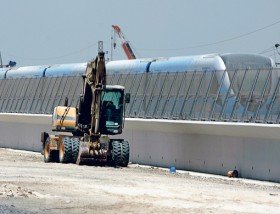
[0,69,280,124]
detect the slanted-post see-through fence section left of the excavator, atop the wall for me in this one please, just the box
[0,76,83,114]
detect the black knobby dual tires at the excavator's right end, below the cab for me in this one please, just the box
[111,141,129,167]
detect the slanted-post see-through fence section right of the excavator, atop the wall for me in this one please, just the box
[107,69,280,123]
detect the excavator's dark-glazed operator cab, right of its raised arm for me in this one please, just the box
[100,86,127,135]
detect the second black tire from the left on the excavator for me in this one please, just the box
[59,137,73,163]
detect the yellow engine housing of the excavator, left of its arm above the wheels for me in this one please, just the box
[52,106,77,132]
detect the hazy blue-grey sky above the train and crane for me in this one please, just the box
[0,0,280,66]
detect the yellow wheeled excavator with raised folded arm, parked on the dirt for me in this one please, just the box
[41,52,130,167]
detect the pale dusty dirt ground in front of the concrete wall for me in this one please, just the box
[0,149,280,214]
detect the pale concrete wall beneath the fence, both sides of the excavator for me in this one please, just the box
[0,114,280,182]
